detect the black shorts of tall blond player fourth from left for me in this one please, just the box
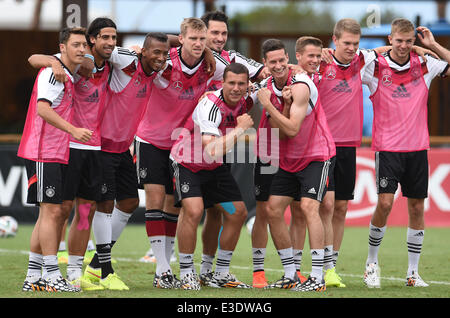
[134,140,173,194]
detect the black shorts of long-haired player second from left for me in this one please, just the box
[63,148,102,201]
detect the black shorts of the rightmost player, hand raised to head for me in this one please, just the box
[375,150,428,199]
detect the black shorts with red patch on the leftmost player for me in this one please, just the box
[25,160,67,205]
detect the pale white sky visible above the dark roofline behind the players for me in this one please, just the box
[0,0,450,32]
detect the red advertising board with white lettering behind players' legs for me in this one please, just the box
[285,148,450,227]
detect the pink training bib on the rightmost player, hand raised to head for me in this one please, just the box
[370,52,430,152]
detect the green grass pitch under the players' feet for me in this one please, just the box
[0,224,450,302]
